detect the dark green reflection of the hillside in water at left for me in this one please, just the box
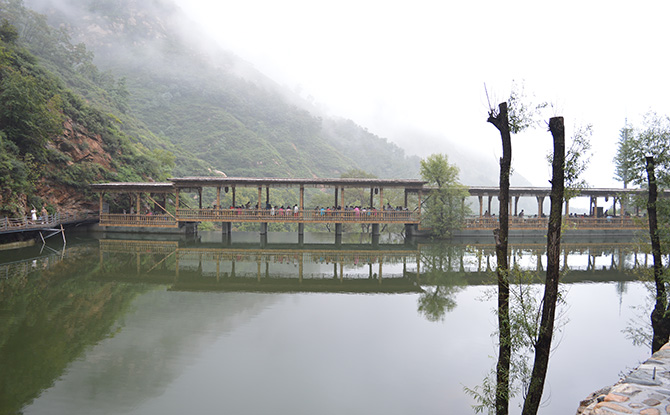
[0,245,146,413]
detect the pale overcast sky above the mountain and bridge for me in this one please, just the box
[177,0,670,187]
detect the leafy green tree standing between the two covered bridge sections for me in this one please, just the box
[421,154,469,238]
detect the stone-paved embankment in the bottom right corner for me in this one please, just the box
[577,343,670,415]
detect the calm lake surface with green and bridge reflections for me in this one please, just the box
[0,233,652,415]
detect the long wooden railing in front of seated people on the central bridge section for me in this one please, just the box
[176,209,421,223]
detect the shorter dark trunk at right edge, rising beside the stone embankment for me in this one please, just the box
[647,157,670,354]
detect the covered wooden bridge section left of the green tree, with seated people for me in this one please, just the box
[91,177,425,234]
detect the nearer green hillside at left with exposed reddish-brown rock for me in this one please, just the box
[0,6,189,215]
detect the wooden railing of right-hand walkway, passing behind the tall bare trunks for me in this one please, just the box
[463,216,648,229]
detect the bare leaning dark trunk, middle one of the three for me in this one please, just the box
[522,117,565,415]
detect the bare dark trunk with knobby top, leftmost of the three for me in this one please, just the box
[487,102,512,415]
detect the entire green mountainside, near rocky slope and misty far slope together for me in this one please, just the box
[0,0,426,215]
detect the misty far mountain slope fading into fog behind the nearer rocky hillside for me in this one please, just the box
[26,0,426,178]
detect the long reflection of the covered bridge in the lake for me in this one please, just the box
[94,239,649,293]
